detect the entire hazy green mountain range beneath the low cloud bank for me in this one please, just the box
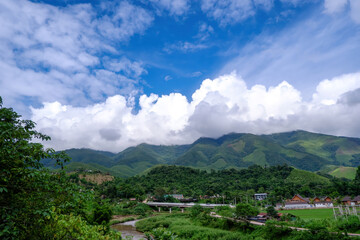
[43,130,360,177]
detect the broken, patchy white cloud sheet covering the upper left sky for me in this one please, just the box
[0,0,153,113]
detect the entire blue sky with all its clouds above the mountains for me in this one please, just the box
[0,0,360,151]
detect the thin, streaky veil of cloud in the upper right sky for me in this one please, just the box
[219,8,360,99]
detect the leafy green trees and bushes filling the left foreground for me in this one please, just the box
[0,97,120,239]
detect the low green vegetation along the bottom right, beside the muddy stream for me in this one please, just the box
[136,204,360,240]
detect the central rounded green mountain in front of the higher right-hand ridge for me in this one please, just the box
[175,134,330,171]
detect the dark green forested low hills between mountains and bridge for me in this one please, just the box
[95,165,360,204]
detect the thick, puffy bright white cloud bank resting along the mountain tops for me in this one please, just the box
[31,70,360,152]
